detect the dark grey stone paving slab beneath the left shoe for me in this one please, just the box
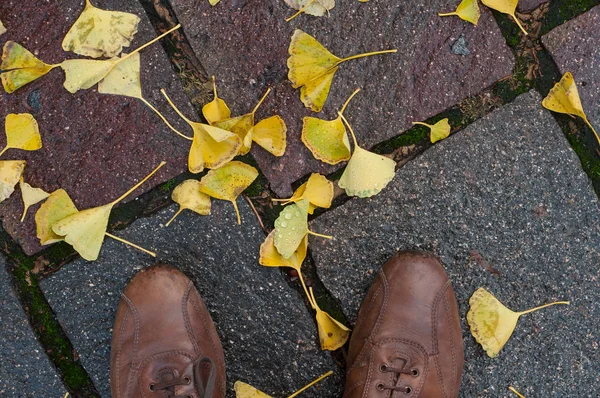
[41,199,342,397]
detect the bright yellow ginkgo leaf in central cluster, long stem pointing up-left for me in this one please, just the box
[161,90,242,174]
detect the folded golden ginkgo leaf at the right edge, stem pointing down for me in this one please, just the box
[542,72,600,144]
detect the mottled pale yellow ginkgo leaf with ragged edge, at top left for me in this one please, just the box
[62,0,140,58]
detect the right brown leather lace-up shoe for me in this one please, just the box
[344,252,464,398]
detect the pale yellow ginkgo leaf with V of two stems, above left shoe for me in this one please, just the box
[52,162,165,261]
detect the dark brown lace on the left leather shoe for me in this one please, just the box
[150,357,217,398]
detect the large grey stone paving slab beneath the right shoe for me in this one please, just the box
[311,92,600,398]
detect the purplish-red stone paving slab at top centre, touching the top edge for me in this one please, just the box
[171,0,514,196]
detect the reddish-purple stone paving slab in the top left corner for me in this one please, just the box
[0,0,192,254]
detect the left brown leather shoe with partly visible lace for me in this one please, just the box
[110,265,225,398]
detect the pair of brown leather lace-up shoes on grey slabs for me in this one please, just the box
[110,252,464,398]
